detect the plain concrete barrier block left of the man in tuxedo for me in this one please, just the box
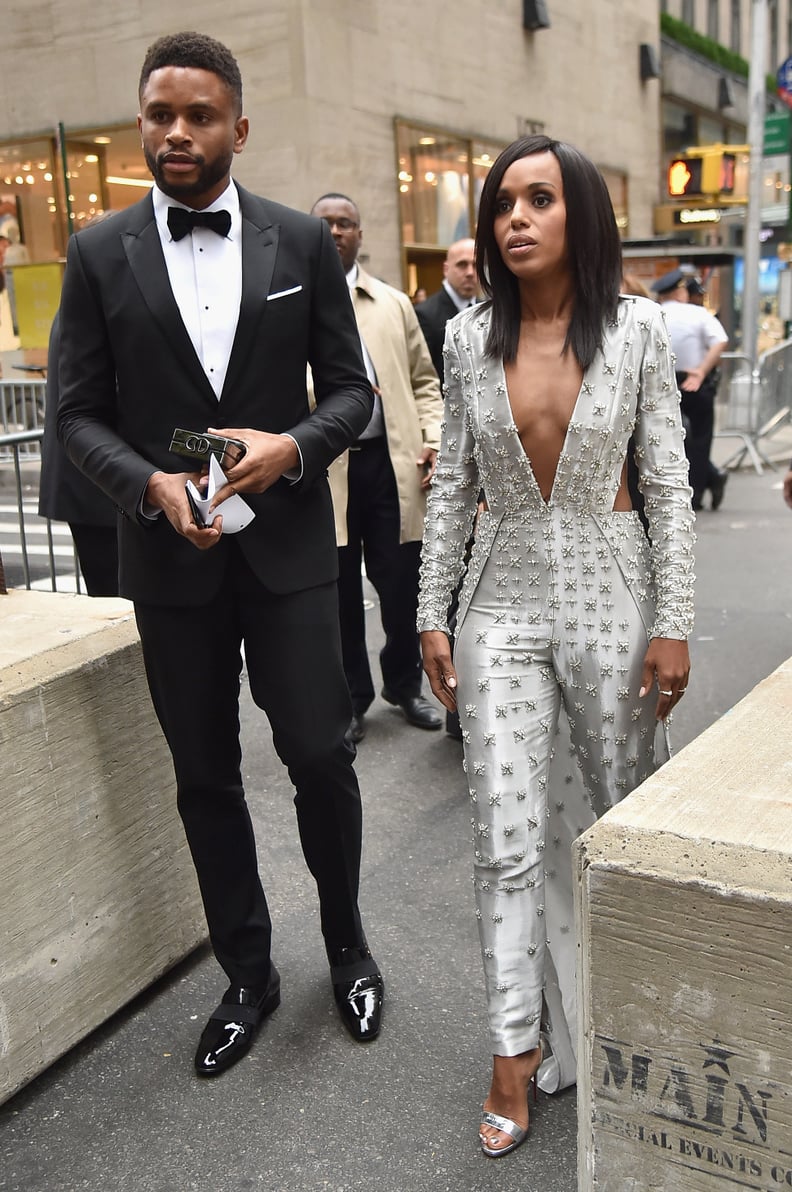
[0,591,206,1101]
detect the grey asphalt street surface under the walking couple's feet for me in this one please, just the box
[0,450,792,1192]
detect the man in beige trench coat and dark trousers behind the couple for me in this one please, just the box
[311,194,443,743]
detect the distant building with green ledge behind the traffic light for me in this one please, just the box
[648,0,792,347]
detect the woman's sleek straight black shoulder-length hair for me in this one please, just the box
[476,136,621,370]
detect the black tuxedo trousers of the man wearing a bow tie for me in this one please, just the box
[135,541,363,986]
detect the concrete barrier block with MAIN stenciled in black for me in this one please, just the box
[574,660,792,1192]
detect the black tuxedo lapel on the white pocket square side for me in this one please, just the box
[221,190,280,401]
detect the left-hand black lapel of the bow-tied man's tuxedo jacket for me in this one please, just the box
[122,213,217,409]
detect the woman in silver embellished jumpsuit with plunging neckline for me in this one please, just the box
[419,137,693,1157]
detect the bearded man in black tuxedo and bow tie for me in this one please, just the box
[58,33,383,1075]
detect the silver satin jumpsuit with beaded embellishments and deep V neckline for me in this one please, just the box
[419,298,693,1091]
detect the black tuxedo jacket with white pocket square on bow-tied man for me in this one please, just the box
[58,187,372,606]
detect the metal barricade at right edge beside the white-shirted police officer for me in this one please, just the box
[714,340,792,476]
